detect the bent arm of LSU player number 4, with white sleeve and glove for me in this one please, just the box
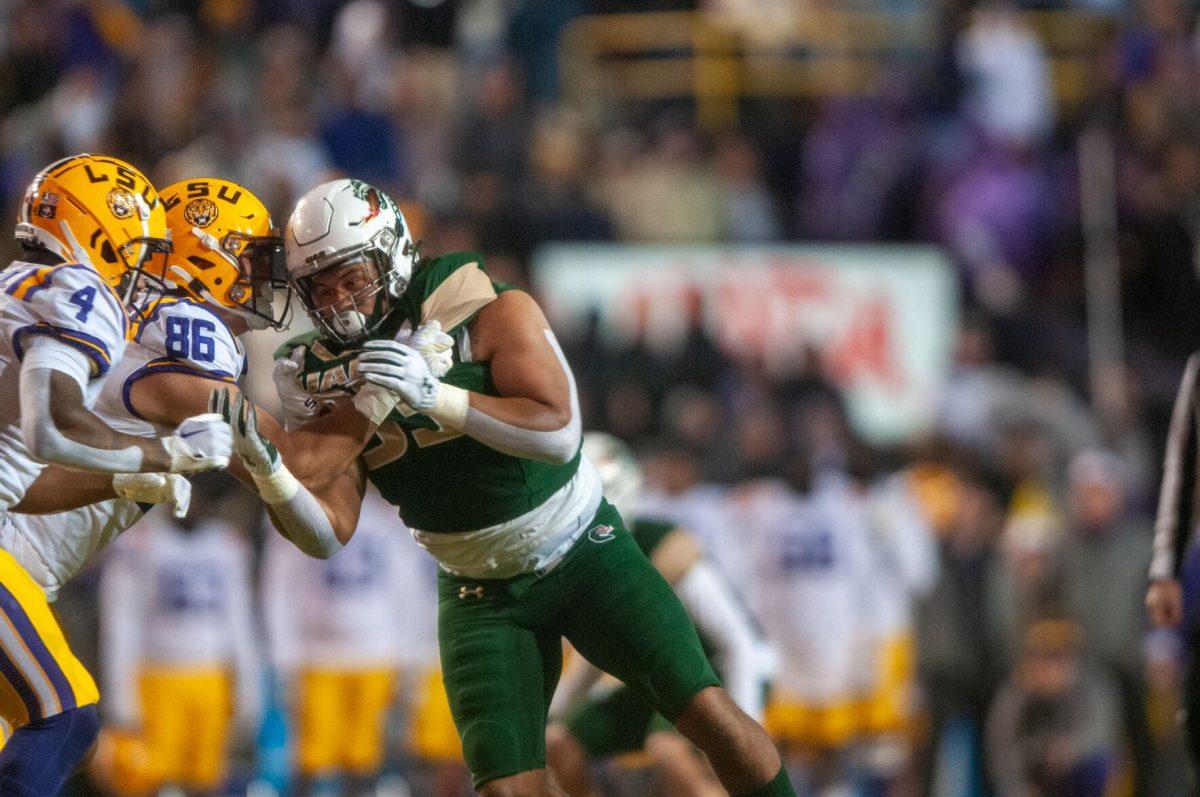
[20,337,230,473]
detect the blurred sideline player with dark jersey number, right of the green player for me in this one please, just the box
[737,472,880,786]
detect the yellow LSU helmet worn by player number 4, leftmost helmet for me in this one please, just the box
[16,154,170,312]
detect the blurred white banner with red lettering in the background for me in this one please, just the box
[534,245,958,443]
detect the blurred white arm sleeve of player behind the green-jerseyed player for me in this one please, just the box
[674,561,767,721]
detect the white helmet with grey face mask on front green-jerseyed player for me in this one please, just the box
[283,180,416,344]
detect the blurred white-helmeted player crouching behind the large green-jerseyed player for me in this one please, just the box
[546,432,778,797]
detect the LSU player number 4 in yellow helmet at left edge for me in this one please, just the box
[0,155,230,796]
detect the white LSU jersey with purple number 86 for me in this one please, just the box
[0,296,246,599]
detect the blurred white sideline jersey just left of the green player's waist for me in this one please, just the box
[262,487,437,670]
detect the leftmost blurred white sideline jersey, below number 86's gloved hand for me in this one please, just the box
[100,519,262,719]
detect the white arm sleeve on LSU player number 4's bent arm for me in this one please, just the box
[20,336,142,473]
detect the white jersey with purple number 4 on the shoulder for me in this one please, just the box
[0,260,128,513]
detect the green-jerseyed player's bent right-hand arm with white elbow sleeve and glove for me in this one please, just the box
[359,290,582,465]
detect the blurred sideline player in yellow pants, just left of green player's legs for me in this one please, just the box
[262,484,415,795]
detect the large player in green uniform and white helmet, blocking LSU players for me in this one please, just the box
[246,180,794,797]
